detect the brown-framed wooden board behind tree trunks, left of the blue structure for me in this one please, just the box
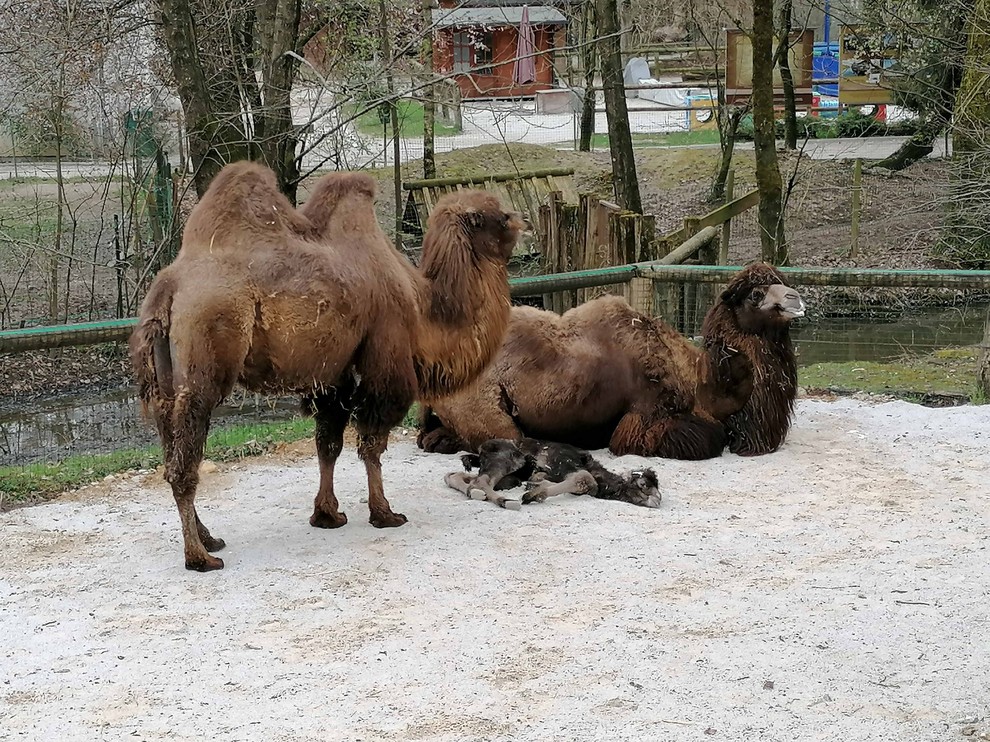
[725,28,815,107]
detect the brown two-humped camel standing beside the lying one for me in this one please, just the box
[131,162,522,571]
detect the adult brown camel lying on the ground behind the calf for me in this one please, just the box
[418,264,804,459]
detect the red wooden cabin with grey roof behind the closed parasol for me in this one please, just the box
[433,0,567,98]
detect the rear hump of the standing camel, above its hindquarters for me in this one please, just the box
[183,161,312,251]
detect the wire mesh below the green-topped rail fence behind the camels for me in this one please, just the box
[0,279,990,488]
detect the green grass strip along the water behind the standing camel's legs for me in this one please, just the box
[0,418,313,504]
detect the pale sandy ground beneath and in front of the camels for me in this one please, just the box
[0,399,990,742]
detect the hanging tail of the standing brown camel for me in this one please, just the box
[130,276,174,413]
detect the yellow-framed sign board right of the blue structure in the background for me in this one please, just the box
[839,26,903,106]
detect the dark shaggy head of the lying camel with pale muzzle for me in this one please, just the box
[719,263,805,334]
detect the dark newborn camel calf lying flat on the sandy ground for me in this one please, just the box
[444,438,661,510]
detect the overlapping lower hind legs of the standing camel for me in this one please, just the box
[163,390,224,572]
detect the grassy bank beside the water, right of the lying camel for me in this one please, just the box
[798,347,984,402]
